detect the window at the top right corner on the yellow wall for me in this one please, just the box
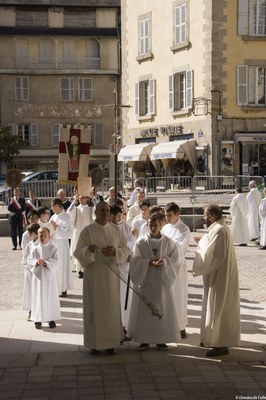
[238,0,266,36]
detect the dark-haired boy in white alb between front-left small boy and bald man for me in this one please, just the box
[49,198,74,297]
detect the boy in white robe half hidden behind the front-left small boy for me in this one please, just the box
[21,223,40,321]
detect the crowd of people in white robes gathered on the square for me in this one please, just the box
[7,181,266,357]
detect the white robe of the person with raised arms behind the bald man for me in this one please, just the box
[68,204,93,271]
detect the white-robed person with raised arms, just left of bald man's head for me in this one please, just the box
[67,192,93,278]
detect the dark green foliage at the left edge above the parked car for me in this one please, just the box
[0,127,21,165]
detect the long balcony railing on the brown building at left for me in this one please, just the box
[11,57,100,70]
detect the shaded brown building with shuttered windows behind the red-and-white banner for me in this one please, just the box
[0,0,120,175]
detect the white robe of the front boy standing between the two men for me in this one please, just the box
[128,235,180,344]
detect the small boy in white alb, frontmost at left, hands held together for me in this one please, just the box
[28,228,61,329]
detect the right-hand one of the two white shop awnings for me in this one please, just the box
[151,139,196,168]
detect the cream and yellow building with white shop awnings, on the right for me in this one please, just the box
[118,0,266,180]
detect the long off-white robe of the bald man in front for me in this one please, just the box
[74,221,130,350]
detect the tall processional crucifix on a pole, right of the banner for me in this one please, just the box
[100,89,132,202]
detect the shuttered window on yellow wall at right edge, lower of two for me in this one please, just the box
[237,65,266,106]
